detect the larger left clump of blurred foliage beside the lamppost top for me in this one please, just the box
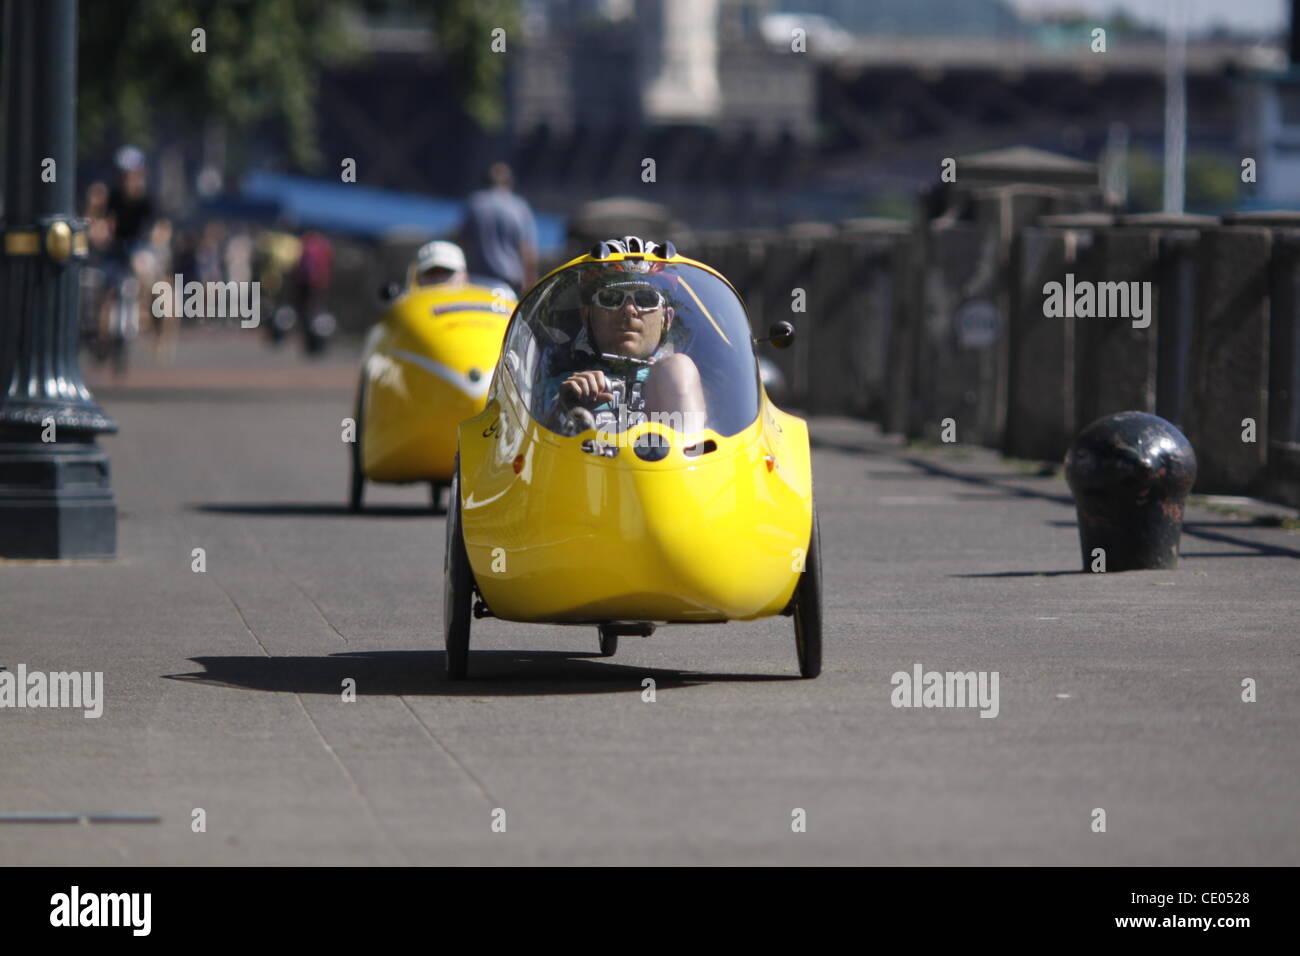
[77,0,359,168]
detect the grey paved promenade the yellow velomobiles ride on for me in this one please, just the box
[0,335,1300,865]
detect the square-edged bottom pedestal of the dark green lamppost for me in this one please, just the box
[0,440,117,559]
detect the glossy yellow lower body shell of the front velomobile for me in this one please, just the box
[460,356,813,623]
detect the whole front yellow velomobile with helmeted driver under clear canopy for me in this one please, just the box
[443,237,822,679]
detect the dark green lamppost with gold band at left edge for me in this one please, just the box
[0,0,117,558]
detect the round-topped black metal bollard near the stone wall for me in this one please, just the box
[1065,411,1196,571]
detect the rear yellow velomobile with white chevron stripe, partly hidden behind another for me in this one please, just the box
[350,269,515,511]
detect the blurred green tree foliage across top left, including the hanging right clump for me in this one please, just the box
[78,0,523,169]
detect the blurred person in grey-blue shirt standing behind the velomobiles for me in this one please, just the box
[460,163,537,291]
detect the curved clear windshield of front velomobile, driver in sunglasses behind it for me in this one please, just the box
[502,260,759,436]
